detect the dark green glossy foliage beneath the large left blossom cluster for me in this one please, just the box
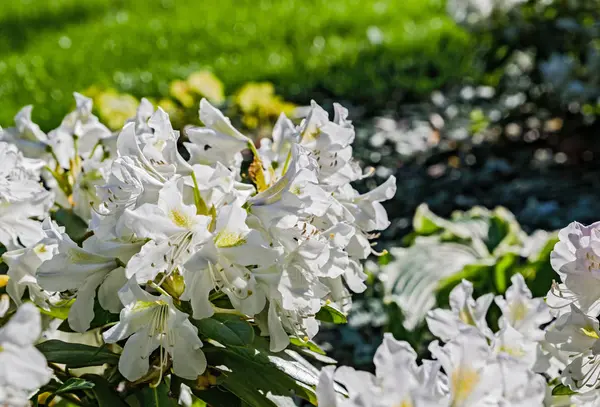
[37,311,326,407]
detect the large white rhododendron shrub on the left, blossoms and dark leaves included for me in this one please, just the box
[0,94,395,406]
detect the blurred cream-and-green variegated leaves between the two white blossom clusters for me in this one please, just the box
[380,204,555,331]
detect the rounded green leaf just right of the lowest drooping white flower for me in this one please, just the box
[193,314,254,346]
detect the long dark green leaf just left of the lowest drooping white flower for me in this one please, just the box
[37,339,119,368]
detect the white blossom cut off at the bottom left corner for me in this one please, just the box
[0,304,52,406]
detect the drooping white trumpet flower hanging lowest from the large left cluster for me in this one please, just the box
[103,280,206,381]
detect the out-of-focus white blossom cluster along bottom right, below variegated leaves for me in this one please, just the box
[317,274,552,407]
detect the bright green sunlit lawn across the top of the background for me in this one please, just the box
[0,0,470,128]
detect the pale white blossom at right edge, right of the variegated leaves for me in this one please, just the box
[547,222,600,316]
